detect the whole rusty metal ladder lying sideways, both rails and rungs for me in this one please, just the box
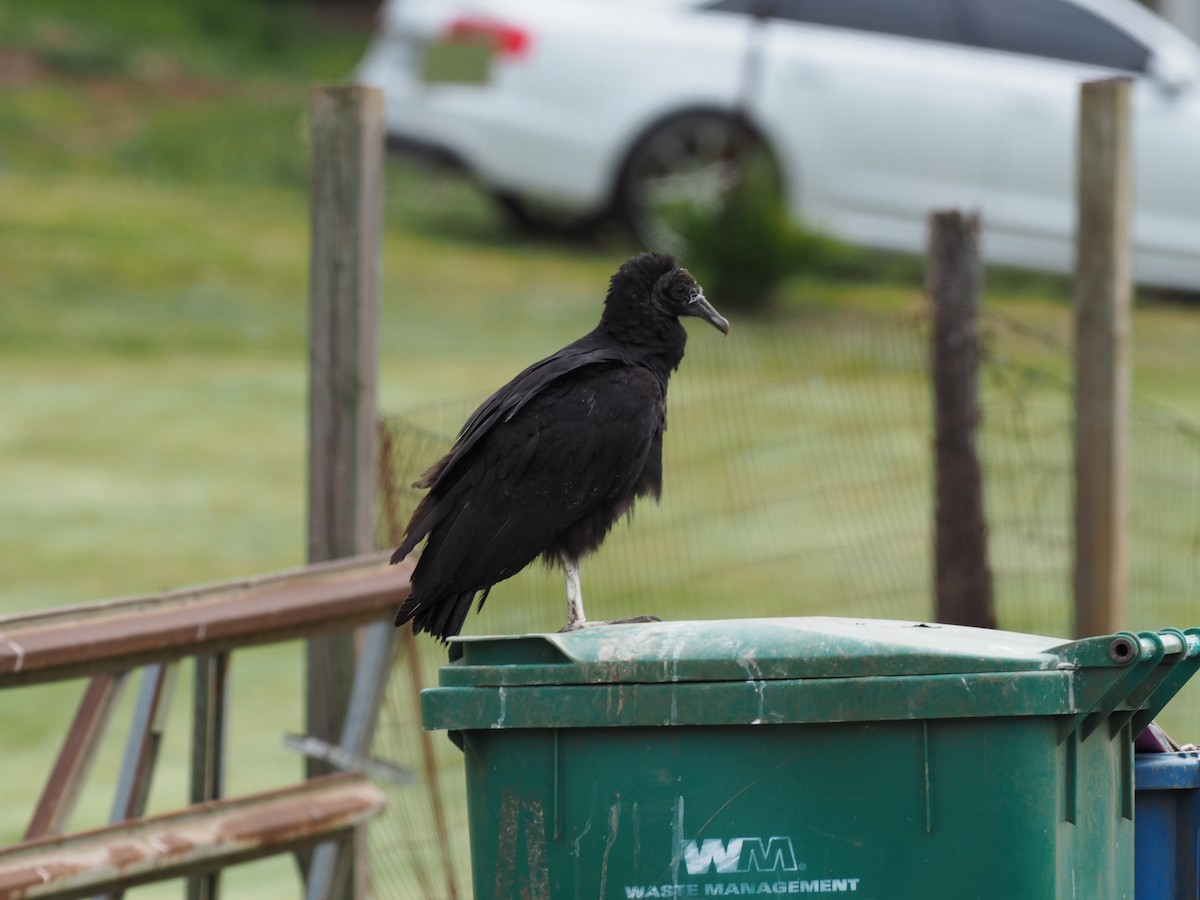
[0,553,410,900]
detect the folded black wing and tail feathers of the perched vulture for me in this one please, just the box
[394,359,666,634]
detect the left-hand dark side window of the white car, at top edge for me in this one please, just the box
[707,0,964,42]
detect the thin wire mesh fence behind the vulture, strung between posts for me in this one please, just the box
[362,314,1200,898]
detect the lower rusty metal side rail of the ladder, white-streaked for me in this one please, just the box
[0,774,384,900]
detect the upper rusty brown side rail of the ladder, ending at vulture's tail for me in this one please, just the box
[0,553,409,688]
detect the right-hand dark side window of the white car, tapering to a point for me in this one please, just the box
[962,0,1150,72]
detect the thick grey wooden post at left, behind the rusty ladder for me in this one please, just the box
[306,84,384,896]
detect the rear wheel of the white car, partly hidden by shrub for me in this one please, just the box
[617,112,779,253]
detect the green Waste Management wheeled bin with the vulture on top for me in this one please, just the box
[421,618,1200,900]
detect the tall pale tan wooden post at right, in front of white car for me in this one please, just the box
[1074,78,1133,637]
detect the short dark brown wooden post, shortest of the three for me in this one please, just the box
[926,210,996,628]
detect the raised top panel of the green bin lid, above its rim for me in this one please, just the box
[442,617,1099,685]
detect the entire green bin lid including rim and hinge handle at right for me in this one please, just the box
[421,617,1200,733]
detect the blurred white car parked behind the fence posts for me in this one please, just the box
[358,0,1200,290]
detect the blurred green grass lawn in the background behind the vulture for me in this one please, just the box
[0,0,1200,898]
